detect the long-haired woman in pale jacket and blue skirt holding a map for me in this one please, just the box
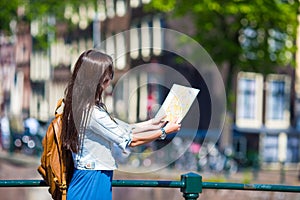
[61,50,181,200]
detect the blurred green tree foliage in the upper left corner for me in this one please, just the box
[0,0,97,49]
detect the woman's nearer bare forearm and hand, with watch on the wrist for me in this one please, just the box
[129,122,181,147]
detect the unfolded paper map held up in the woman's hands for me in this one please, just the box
[155,84,200,123]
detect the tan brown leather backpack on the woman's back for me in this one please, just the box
[38,99,74,200]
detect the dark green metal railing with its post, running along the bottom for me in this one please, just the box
[0,173,300,200]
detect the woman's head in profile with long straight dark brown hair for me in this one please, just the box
[61,49,114,153]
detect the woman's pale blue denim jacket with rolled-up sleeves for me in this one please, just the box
[73,106,132,170]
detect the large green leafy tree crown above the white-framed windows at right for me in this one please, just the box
[148,0,299,108]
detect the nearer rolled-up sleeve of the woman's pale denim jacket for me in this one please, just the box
[89,107,132,152]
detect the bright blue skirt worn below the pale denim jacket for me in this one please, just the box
[67,169,113,200]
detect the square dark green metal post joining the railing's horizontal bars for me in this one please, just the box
[180,173,202,200]
